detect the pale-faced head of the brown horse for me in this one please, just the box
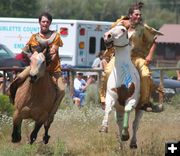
[29,49,46,83]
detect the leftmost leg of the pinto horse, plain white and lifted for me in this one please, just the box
[99,94,115,133]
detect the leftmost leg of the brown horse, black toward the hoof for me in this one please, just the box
[11,110,22,143]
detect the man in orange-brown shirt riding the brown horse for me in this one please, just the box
[10,12,65,104]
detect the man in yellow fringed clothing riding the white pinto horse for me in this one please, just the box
[100,2,162,111]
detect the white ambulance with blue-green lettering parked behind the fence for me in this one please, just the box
[0,18,112,67]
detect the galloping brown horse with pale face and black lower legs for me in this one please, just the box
[12,51,59,144]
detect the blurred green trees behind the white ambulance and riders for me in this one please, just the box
[0,0,180,28]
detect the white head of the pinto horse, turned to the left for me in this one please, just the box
[104,25,129,48]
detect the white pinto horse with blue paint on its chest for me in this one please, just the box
[100,25,143,148]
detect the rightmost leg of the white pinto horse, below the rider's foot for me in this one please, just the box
[130,110,143,148]
